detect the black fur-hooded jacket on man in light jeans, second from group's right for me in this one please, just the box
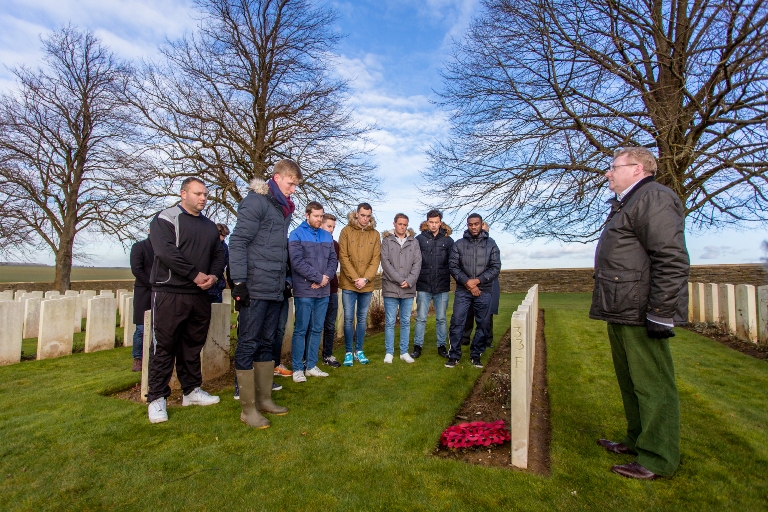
[416,222,453,293]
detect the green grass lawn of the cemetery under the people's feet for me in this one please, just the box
[0,294,768,511]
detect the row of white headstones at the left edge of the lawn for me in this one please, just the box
[0,290,133,365]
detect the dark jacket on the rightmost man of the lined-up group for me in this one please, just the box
[449,230,501,293]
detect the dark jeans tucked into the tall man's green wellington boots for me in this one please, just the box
[235,299,285,370]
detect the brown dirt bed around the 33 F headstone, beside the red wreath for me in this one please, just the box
[434,311,552,476]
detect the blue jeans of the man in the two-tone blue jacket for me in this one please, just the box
[291,297,328,371]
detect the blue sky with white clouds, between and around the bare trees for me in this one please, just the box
[0,0,768,269]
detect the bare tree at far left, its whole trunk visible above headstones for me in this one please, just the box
[0,26,160,291]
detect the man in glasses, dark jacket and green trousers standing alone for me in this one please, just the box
[589,148,690,480]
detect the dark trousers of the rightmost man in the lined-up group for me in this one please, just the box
[448,288,491,359]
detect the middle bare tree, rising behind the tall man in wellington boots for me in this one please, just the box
[134,0,378,215]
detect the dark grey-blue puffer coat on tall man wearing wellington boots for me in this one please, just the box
[229,178,291,301]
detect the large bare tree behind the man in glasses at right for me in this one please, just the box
[424,0,768,241]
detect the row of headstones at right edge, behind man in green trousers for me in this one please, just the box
[688,283,768,343]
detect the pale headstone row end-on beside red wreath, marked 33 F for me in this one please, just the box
[509,284,539,468]
